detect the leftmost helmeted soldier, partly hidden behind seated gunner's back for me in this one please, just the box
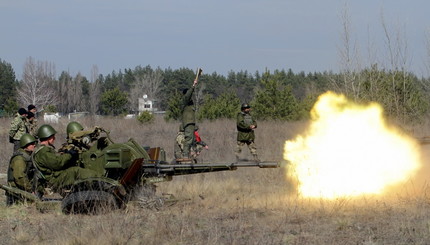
[6,134,37,206]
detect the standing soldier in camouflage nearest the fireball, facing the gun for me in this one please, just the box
[235,103,260,161]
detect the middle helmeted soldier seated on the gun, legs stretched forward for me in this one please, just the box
[33,124,101,192]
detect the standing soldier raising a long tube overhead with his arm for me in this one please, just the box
[182,79,197,159]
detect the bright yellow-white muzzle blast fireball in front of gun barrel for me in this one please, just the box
[284,92,422,199]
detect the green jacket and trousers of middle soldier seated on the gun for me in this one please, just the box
[33,145,101,192]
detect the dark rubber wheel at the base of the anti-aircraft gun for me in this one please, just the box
[61,191,119,214]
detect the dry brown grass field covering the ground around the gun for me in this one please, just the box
[0,118,430,244]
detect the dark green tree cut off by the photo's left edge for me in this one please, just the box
[0,59,18,115]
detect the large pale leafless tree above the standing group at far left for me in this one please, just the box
[18,57,58,107]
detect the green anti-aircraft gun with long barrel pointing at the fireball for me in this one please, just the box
[0,128,279,214]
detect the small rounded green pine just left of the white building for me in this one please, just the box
[100,87,128,116]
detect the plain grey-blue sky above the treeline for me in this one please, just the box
[0,0,430,79]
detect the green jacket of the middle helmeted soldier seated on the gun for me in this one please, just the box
[33,144,72,181]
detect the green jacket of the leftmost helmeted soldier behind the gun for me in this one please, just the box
[7,149,34,192]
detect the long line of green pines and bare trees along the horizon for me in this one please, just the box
[0,58,429,121]
